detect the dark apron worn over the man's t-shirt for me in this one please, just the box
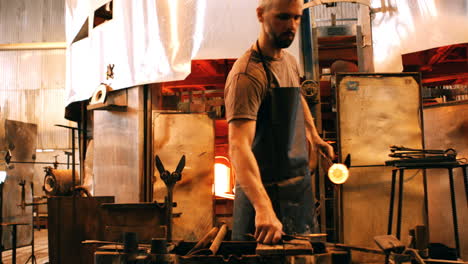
[232,42,318,241]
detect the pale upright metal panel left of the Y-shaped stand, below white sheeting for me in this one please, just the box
[93,87,144,203]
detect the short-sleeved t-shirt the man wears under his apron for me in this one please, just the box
[224,48,300,122]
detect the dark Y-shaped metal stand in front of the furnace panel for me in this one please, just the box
[155,155,185,242]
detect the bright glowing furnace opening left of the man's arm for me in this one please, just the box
[214,156,234,199]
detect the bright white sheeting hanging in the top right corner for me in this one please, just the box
[372,0,468,72]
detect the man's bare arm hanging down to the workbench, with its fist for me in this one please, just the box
[229,119,283,244]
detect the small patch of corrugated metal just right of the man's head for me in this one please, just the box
[311,3,359,27]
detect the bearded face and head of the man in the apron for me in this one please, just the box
[260,0,302,49]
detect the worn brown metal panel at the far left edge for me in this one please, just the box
[1,120,37,249]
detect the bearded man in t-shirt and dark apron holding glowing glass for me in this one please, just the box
[225,0,333,244]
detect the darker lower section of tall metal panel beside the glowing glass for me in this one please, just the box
[343,167,425,263]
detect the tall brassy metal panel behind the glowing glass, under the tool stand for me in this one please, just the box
[337,73,426,262]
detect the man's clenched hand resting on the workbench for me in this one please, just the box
[254,209,283,244]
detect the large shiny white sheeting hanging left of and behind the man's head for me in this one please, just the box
[66,0,299,104]
